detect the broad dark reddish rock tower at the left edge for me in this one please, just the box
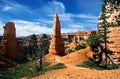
[0,22,18,59]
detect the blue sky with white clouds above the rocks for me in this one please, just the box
[0,0,102,37]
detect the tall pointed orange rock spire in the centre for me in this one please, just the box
[49,14,65,56]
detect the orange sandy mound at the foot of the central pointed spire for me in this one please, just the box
[44,47,93,65]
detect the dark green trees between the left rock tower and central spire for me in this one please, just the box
[15,34,49,63]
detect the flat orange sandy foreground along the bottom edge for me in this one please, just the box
[33,67,120,79]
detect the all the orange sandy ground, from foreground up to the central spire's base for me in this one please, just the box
[32,49,120,79]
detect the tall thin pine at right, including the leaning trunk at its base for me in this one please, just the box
[98,0,117,68]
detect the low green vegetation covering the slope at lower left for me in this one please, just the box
[0,60,65,79]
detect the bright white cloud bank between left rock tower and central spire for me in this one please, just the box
[11,20,52,36]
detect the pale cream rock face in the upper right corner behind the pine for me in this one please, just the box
[98,0,120,27]
